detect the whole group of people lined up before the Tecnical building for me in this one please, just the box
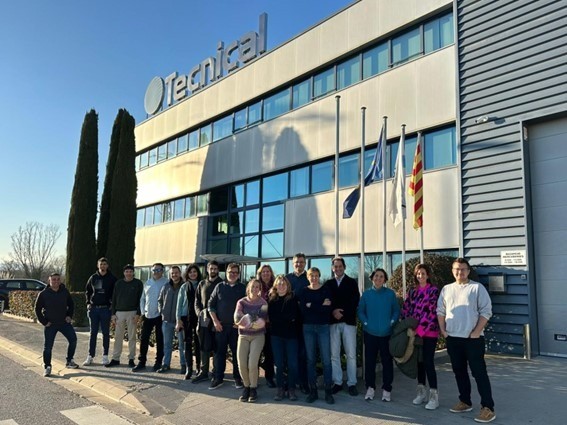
[36,253,496,422]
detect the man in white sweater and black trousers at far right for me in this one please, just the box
[437,258,496,423]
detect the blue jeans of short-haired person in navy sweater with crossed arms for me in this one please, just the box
[303,323,333,388]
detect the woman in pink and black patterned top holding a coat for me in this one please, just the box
[401,264,439,410]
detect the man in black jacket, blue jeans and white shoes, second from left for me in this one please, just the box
[83,257,116,366]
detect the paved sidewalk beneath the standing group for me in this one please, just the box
[0,315,567,425]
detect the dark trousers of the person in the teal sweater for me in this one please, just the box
[364,332,394,391]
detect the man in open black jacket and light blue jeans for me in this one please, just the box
[325,257,360,396]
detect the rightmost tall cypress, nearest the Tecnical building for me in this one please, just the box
[103,110,138,270]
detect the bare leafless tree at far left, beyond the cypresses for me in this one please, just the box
[5,221,61,279]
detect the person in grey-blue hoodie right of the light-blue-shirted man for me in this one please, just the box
[156,266,186,373]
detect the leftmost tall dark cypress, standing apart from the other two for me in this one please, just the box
[65,109,98,291]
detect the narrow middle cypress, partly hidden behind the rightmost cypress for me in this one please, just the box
[96,109,125,258]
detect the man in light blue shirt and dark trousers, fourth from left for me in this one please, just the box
[132,263,167,372]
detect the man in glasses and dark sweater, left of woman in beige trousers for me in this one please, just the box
[209,263,246,390]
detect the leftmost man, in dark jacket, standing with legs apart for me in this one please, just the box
[35,273,79,376]
